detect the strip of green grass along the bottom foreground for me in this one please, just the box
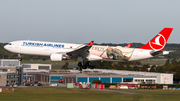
[0,87,180,101]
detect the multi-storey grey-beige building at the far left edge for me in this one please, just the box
[0,59,23,86]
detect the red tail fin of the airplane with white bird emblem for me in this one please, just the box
[138,28,173,51]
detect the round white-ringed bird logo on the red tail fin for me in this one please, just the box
[149,34,166,50]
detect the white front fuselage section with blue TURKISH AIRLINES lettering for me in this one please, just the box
[4,40,80,56]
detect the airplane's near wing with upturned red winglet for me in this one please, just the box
[66,41,94,58]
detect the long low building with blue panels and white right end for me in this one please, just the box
[24,69,173,84]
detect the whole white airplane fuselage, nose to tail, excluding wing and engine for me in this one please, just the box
[4,40,158,61]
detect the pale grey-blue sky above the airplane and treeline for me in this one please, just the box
[0,0,180,43]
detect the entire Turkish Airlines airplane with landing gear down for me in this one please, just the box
[4,28,173,69]
